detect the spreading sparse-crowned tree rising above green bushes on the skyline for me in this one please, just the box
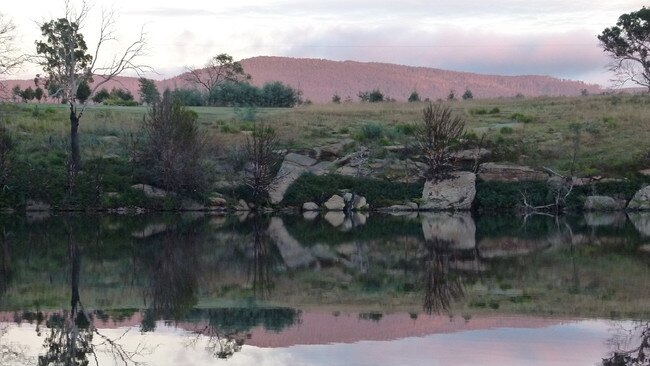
[186,53,251,103]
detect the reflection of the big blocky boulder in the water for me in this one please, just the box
[420,212,476,250]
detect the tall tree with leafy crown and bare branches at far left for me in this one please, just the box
[36,0,151,172]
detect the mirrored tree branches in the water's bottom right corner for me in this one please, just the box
[603,322,650,366]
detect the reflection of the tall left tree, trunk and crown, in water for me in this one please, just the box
[37,226,142,366]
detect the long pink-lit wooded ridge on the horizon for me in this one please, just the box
[3,56,604,103]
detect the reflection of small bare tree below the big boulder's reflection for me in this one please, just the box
[423,238,465,314]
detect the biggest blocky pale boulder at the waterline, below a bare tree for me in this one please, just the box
[420,172,476,210]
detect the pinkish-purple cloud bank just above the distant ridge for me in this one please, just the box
[283,25,607,82]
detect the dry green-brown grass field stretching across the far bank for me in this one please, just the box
[0,95,650,209]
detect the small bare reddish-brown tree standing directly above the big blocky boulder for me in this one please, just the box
[415,103,465,179]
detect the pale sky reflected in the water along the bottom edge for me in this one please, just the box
[2,320,628,366]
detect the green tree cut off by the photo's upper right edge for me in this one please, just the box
[598,6,650,91]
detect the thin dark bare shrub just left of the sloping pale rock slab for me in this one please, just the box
[244,122,280,207]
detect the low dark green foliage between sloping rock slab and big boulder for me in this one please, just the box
[283,174,422,207]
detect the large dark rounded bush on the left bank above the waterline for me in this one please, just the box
[131,93,207,195]
